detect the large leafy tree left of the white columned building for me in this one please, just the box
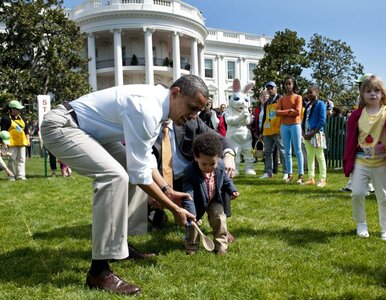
[0,0,91,110]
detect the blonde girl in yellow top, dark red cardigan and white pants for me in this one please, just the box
[343,75,386,241]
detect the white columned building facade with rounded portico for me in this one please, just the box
[66,0,272,106]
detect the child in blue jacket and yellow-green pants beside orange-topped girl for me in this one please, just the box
[302,86,327,187]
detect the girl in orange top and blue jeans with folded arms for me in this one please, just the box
[276,76,304,184]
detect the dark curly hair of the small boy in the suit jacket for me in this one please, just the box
[193,132,223,157]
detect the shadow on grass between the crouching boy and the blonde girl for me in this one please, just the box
[232,228,354,247]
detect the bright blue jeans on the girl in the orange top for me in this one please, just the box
[280,124,304,175]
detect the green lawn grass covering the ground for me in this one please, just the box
[0,158,386,299]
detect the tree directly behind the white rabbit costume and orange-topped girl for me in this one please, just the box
[254,29,309,96]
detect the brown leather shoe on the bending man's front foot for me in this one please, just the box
[86,270,141,295]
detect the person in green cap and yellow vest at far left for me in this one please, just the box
[1,100,29,181]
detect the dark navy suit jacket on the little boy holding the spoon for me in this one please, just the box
[182,159,237,220]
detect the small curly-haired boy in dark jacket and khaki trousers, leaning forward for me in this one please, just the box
[182,132,239,255]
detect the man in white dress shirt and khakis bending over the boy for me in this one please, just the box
[41,75,209,294]
